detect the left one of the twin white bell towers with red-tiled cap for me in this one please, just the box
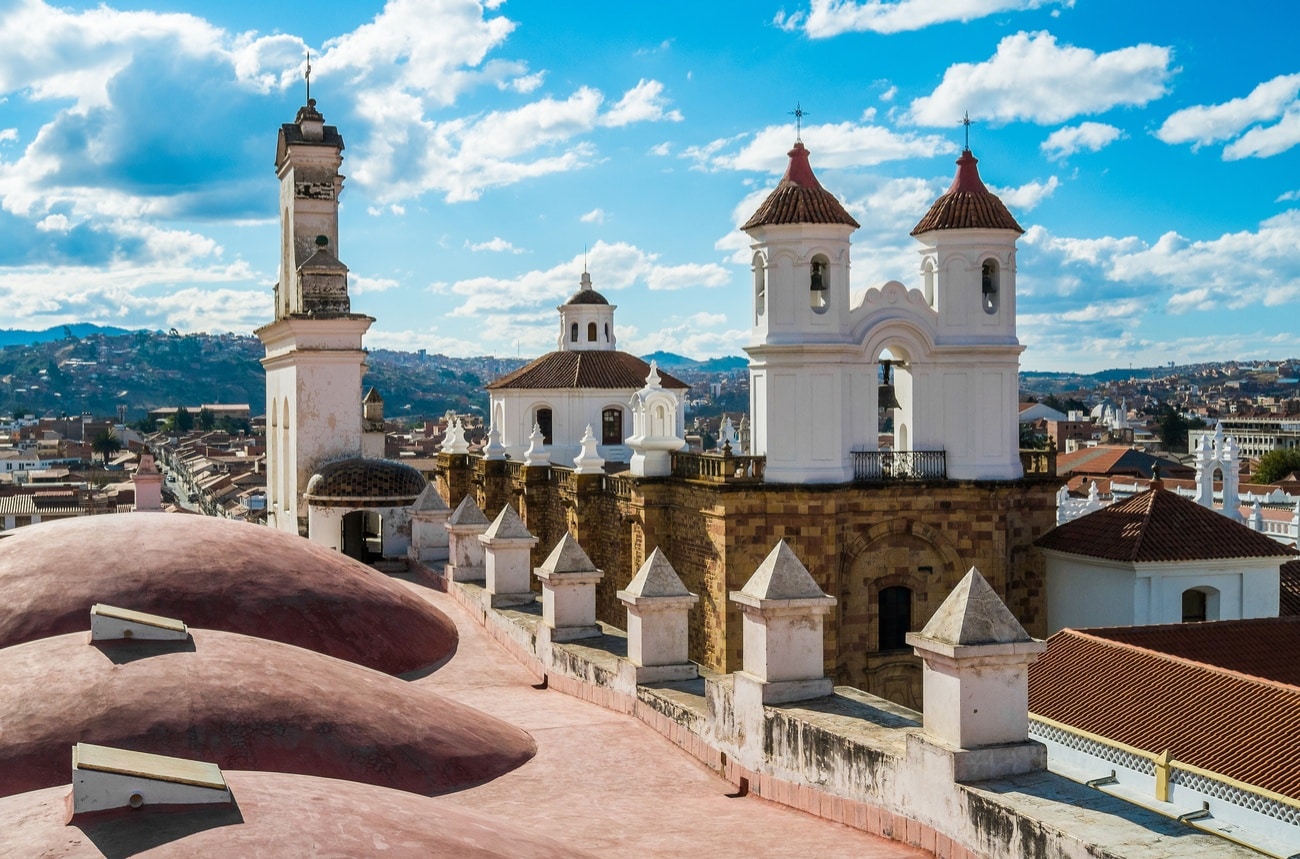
[741,142,858,483]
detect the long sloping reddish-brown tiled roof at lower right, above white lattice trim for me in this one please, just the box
[1030,624,1300,798]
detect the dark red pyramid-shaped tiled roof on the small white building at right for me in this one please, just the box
[1035,487,1296,563]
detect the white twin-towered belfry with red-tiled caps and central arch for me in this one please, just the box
[741,142,1023,483]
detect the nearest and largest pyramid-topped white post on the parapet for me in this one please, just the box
[907,567,1047,781]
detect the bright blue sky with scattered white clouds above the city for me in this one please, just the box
[0,0,1300,372]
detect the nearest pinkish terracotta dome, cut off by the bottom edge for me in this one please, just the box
[0,772,590,859]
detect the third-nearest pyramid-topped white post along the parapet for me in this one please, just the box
[618,548,699,684]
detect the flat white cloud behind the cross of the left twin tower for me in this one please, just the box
[681,122,957,173]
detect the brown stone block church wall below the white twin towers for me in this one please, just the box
[438,457,1057,708]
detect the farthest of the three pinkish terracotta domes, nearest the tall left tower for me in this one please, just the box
[0,513,456,674]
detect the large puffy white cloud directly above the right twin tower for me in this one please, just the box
[907,32,1173,126]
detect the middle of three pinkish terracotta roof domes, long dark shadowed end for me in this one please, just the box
[0,626,537,795]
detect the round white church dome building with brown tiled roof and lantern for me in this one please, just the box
[488,272,689,467]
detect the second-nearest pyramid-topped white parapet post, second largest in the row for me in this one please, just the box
[731,541,836,708]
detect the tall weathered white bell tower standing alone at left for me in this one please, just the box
[256,99,374,534]
